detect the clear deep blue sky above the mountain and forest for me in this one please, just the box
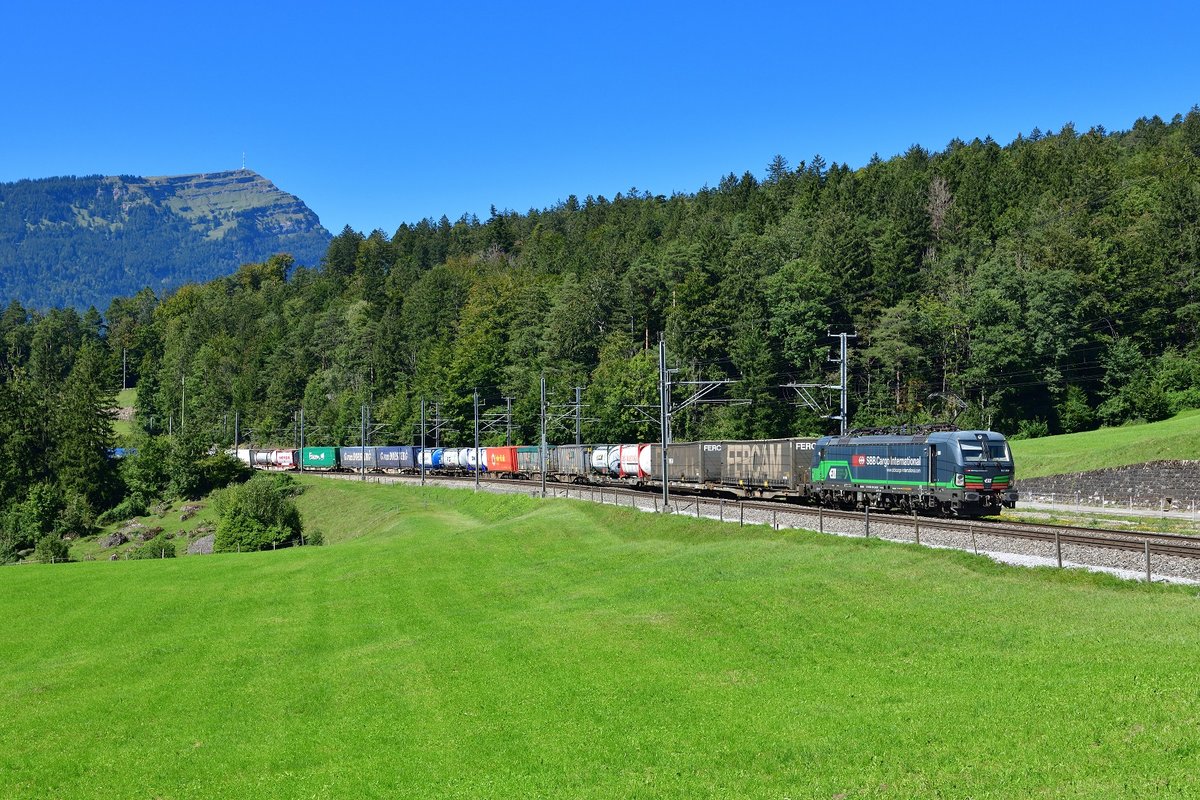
[0,0,1200,234]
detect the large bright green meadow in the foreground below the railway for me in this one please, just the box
[0,479,1200,799]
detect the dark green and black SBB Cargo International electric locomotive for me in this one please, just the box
[811,428,1016,517]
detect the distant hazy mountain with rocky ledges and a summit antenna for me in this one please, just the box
[0,170,331,308]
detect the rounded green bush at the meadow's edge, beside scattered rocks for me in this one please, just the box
[214,475,302,553]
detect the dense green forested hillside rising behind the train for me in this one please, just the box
[0,108,1200,556]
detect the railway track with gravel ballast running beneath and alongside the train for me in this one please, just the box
[310,473,1200,578]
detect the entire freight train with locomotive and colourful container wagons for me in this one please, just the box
[235,428,1018,517]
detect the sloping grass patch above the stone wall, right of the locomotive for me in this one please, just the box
[1012,410,1200,479]
